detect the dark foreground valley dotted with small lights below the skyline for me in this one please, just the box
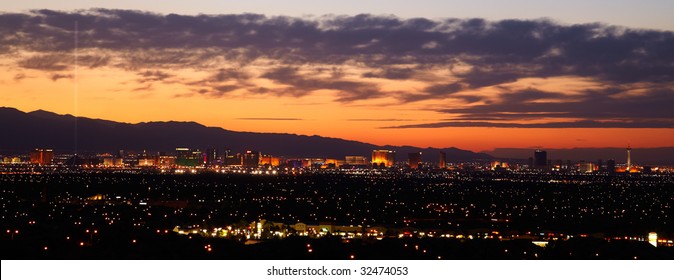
[0,172,674,259]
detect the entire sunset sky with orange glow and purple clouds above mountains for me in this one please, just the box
[0,0,674,151]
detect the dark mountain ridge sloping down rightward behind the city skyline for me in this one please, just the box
[0,107,492,162]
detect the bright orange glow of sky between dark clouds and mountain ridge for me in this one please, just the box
[0,59,674,152]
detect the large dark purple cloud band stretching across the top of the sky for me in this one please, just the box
[0,9,674,82]
